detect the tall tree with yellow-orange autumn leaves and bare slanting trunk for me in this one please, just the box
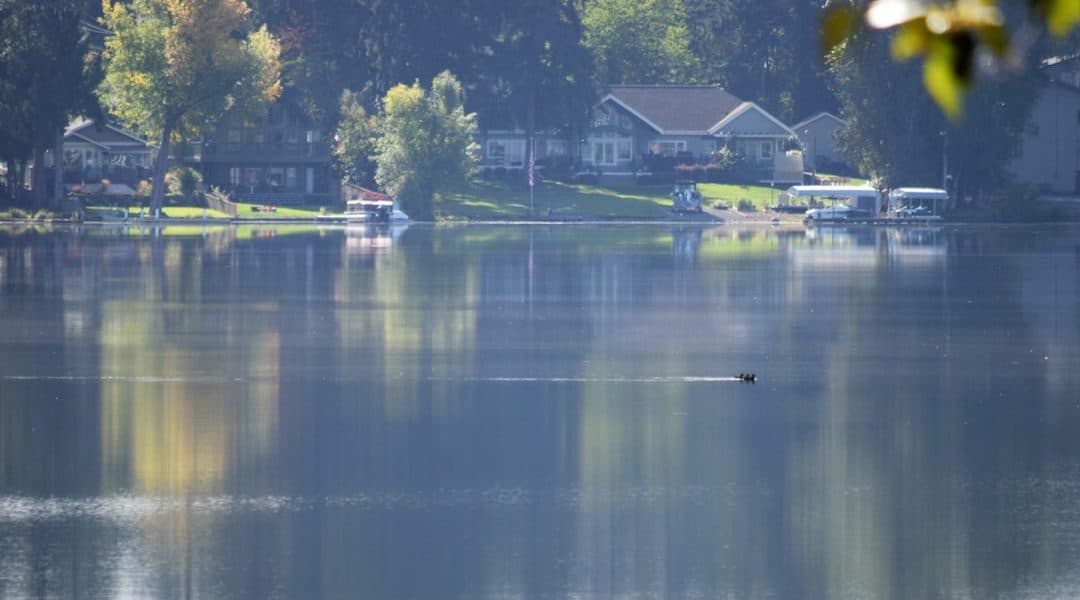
[99,0,281,214]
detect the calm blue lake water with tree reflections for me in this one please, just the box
[0,224,1080,599]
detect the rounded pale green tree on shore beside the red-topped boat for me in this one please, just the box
[375,71,477,220]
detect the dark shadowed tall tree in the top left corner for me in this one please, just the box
[0,0,96,202]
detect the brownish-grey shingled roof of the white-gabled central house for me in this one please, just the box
[608,85,743,132]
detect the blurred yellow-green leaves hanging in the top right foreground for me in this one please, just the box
[823,0,1080,121]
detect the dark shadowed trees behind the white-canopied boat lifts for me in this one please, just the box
[829,26,1040,196]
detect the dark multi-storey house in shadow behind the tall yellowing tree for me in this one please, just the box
[179,96,340,204]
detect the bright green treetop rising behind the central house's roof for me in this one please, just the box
[581,0,701,85]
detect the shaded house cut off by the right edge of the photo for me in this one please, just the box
[1009,56,1080,195]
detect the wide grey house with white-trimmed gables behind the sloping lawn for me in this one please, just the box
[478,85,802,182]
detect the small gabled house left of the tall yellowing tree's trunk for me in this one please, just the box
[57,119,153,190]
